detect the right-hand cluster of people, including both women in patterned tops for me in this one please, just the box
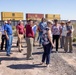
[38,18,74,66]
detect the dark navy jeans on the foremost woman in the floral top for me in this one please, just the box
[42,43,52,64]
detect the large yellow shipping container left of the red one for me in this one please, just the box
[1,12,23,20]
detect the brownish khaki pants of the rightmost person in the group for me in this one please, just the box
[64,36,73,52]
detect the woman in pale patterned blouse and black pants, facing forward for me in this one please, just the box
[52,19,62,53]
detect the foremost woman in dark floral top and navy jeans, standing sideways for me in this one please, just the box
[41,21,54,66]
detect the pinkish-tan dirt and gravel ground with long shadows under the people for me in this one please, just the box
[0,38,76,75]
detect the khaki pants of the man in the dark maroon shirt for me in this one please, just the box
[26,38,33,58]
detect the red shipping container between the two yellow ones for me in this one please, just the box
[26,13,44,21]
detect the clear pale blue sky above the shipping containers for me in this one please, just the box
[0,0,76,20]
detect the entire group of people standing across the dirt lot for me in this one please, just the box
[0,18,74,66]
